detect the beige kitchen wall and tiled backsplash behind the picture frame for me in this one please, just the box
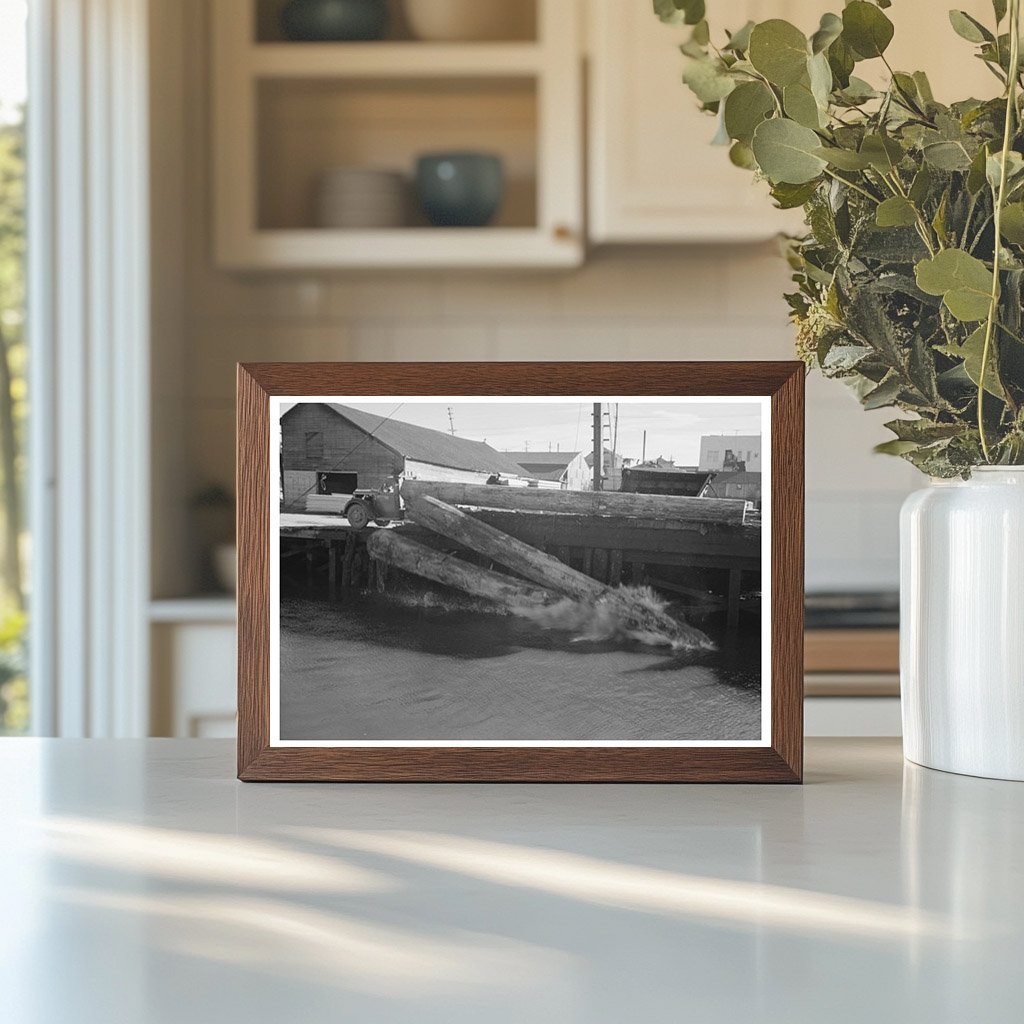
[158,0,919,589]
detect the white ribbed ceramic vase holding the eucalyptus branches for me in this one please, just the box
[900,466,1024,781]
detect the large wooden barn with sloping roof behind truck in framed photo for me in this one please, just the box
[281,402,527,511]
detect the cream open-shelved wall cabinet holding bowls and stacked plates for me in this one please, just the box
[211,0,584,269]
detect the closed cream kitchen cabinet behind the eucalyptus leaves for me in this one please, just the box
[587,0,997,244]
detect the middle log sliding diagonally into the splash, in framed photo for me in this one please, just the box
[406,488,608,601]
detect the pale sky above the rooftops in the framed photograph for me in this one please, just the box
[301,398,761,465]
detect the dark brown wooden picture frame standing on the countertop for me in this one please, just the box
[238,361,804,782]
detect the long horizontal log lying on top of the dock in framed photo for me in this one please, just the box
[401,480,748,526]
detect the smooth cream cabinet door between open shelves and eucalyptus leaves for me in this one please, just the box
[588,0,811,243]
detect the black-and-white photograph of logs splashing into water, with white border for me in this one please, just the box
[270,395,771,746]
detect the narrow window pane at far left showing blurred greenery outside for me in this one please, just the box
[0,0,30,734]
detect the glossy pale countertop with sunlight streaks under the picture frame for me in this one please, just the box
[0,739,1024,1024]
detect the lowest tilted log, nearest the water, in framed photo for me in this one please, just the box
[367,529,558,607]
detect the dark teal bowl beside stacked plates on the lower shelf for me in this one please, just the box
[416,153,505,227]
